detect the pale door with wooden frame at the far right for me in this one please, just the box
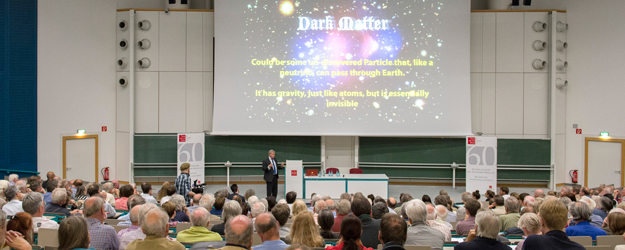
[584,138,625,187]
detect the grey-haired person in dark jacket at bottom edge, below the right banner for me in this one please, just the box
[454,211,516,250]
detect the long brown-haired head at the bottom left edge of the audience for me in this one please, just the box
[58,216,91,250]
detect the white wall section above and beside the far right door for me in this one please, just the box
[562,0,625,184]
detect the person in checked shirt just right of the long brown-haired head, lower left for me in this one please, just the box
[84,197,119,249]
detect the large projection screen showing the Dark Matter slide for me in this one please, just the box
[213,0,471,136]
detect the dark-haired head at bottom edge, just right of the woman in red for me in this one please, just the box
[378,214,408,250]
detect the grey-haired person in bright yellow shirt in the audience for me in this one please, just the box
[176,207,222,243]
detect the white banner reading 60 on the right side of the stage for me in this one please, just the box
[466,136,497,195]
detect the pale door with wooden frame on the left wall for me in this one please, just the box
[63,135,98,182]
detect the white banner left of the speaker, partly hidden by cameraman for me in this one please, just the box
[177,133,204,185]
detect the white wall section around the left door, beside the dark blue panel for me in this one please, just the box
[37,0,117,182]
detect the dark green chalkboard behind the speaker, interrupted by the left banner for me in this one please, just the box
[134,134,321,164]
